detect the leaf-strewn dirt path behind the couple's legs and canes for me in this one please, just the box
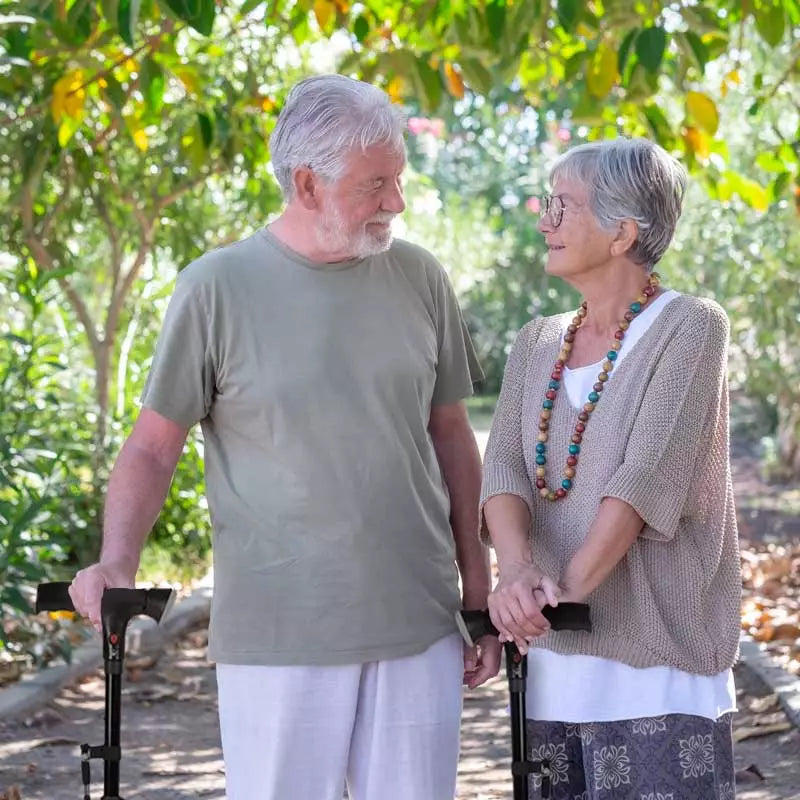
[0,629,800,800]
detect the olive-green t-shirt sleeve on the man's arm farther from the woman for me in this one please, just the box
[142,274,216,428]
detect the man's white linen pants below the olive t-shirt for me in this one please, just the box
[217,634,464,800]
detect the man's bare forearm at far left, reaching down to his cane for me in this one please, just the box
[100,440,174,580]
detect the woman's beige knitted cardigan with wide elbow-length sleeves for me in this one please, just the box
[481,295,741,675]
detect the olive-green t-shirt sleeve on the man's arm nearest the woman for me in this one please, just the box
[432,265,484,406]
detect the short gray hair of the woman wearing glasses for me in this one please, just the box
[550,138,687,271]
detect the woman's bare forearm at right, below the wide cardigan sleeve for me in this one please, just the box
[559,497,644,601]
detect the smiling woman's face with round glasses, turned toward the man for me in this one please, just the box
[538,178,614,280]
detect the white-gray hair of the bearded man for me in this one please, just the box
[269,75,406,200]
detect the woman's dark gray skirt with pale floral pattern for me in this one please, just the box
[527,714,736,800]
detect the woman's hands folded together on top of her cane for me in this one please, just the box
[488,562,561,655]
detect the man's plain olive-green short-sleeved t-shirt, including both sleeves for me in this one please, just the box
[143,229,481,664]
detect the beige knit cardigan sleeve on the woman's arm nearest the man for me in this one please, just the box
[480,322,539,542]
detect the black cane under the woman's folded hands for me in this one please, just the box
[456,603,592,800]
